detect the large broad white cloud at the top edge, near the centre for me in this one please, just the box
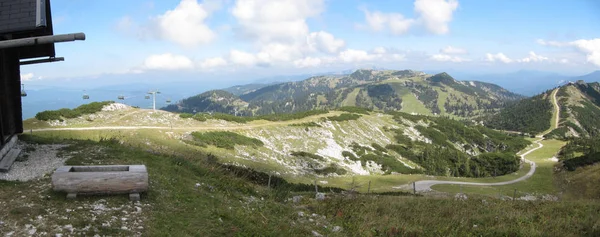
[231,0,324,42]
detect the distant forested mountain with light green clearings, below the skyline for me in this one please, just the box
[163,69,522,118]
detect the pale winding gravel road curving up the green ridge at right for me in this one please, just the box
[408,89,560,192]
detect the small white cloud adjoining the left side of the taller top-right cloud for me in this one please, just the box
[364,10,414,35]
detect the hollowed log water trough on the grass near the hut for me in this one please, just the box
[52,165,148,201]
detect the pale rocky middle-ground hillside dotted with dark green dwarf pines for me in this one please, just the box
[25,103,529,177]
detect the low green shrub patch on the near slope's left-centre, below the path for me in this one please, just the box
[192,132,264,149]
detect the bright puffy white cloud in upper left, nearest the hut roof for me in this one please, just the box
[156,0,216,47]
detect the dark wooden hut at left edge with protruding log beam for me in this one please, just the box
[0,0,85,172]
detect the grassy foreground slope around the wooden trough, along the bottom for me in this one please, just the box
[0,137,600,236]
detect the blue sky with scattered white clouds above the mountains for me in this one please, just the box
[21,0,600,84]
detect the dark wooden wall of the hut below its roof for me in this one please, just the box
[0,49,23,147]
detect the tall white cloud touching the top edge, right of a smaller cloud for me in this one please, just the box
[414,0,458,35]
